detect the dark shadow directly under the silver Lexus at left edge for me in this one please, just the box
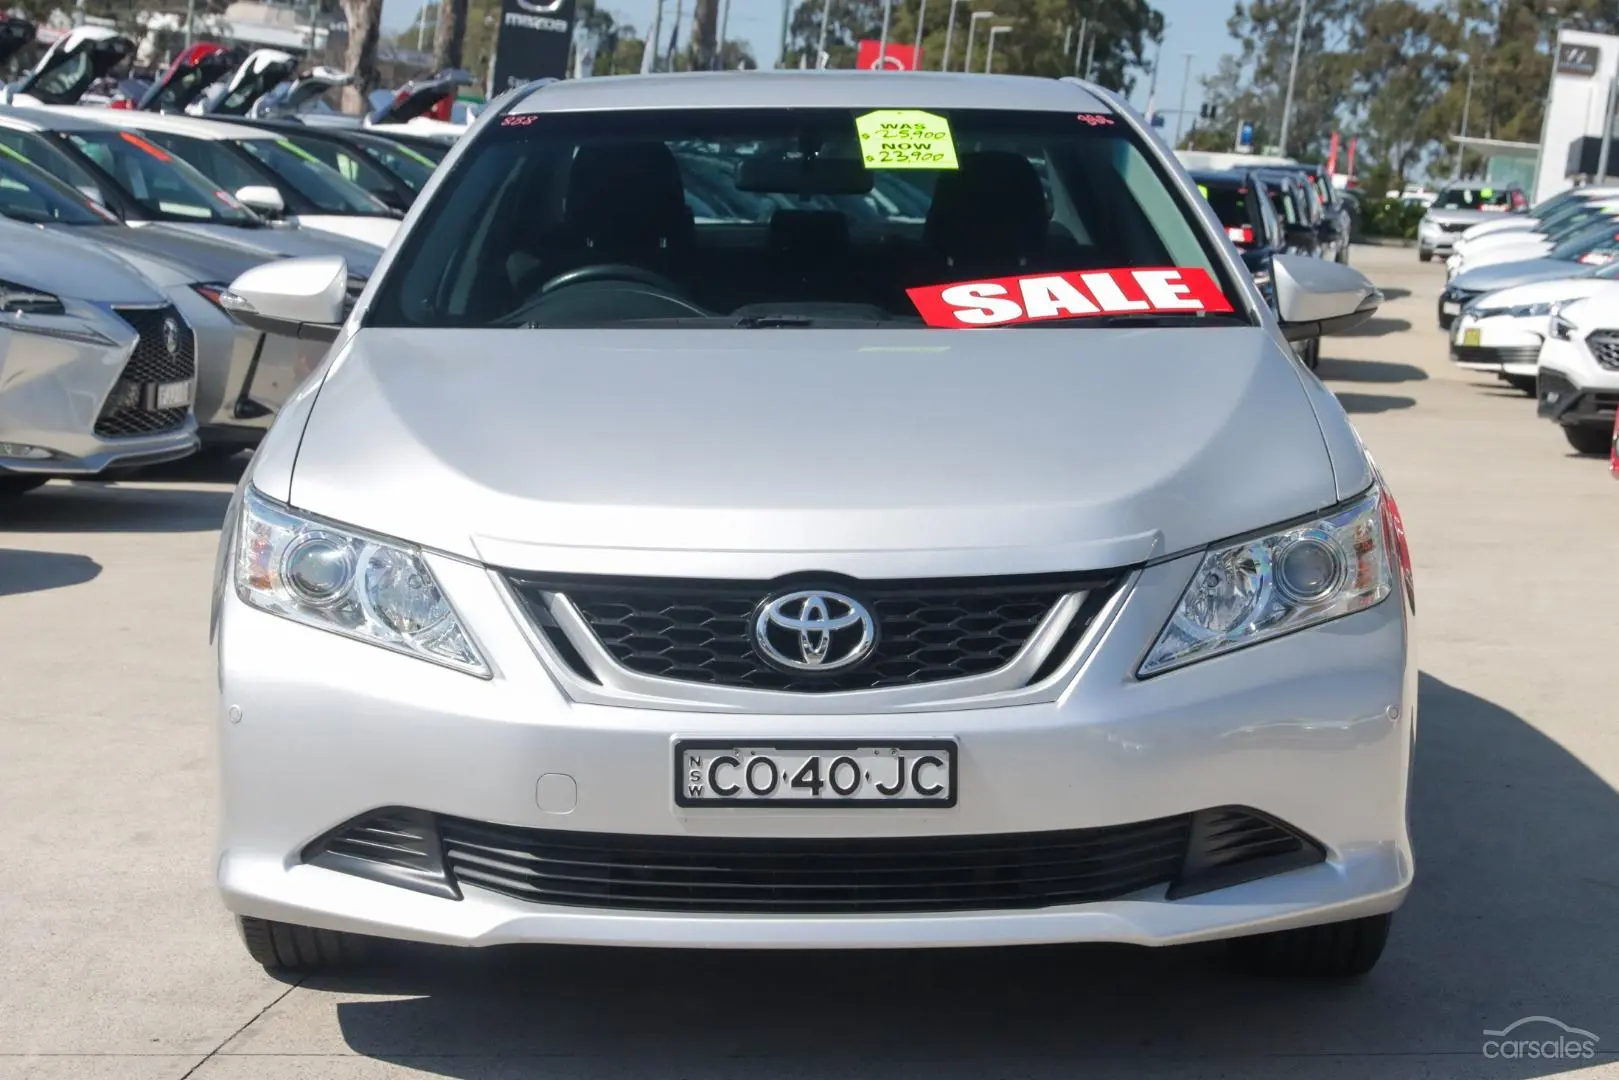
[0,476,230,534]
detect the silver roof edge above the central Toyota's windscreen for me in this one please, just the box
[512,70,1114,113]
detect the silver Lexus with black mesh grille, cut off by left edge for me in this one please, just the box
[0,217,198,497]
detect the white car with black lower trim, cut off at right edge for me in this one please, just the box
[1536,290,1619,455]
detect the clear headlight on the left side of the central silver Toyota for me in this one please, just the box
[235,487,489,678]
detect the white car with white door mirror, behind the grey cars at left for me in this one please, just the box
[41,107,400,248]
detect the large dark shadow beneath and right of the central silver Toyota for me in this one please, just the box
[298,675,1619,1080]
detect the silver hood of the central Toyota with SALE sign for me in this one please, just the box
[288,327,1337,576]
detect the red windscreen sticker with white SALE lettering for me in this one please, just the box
[905,267,1232,330]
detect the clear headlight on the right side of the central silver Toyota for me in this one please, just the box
[1140,486,1404,677]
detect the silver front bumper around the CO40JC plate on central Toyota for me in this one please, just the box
[217,544,1417,947]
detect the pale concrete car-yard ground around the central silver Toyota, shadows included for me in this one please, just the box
[0,248,1619,1080]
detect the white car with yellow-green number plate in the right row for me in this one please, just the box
[1451,270,1619,395]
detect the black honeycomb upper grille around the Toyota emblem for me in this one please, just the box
[513,576,1117,693]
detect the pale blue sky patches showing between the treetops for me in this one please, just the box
[382,0,1232,113]
